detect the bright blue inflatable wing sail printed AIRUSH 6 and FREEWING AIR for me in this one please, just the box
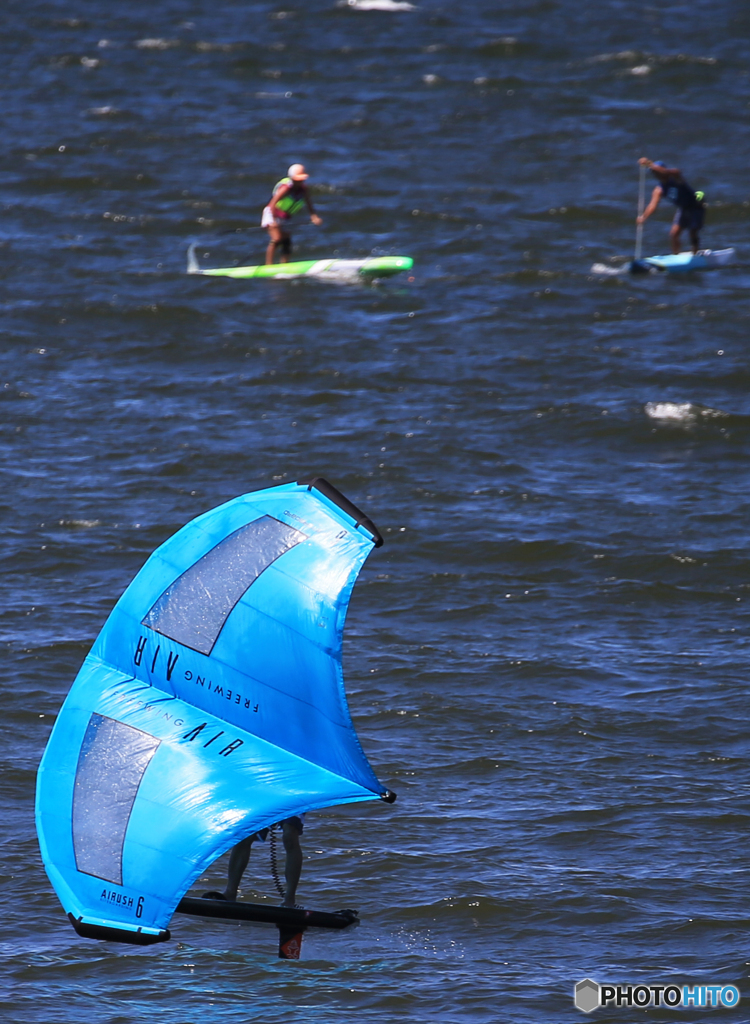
[37,479,391,943]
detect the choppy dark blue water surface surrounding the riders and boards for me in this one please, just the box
[0,0,750,1024]
